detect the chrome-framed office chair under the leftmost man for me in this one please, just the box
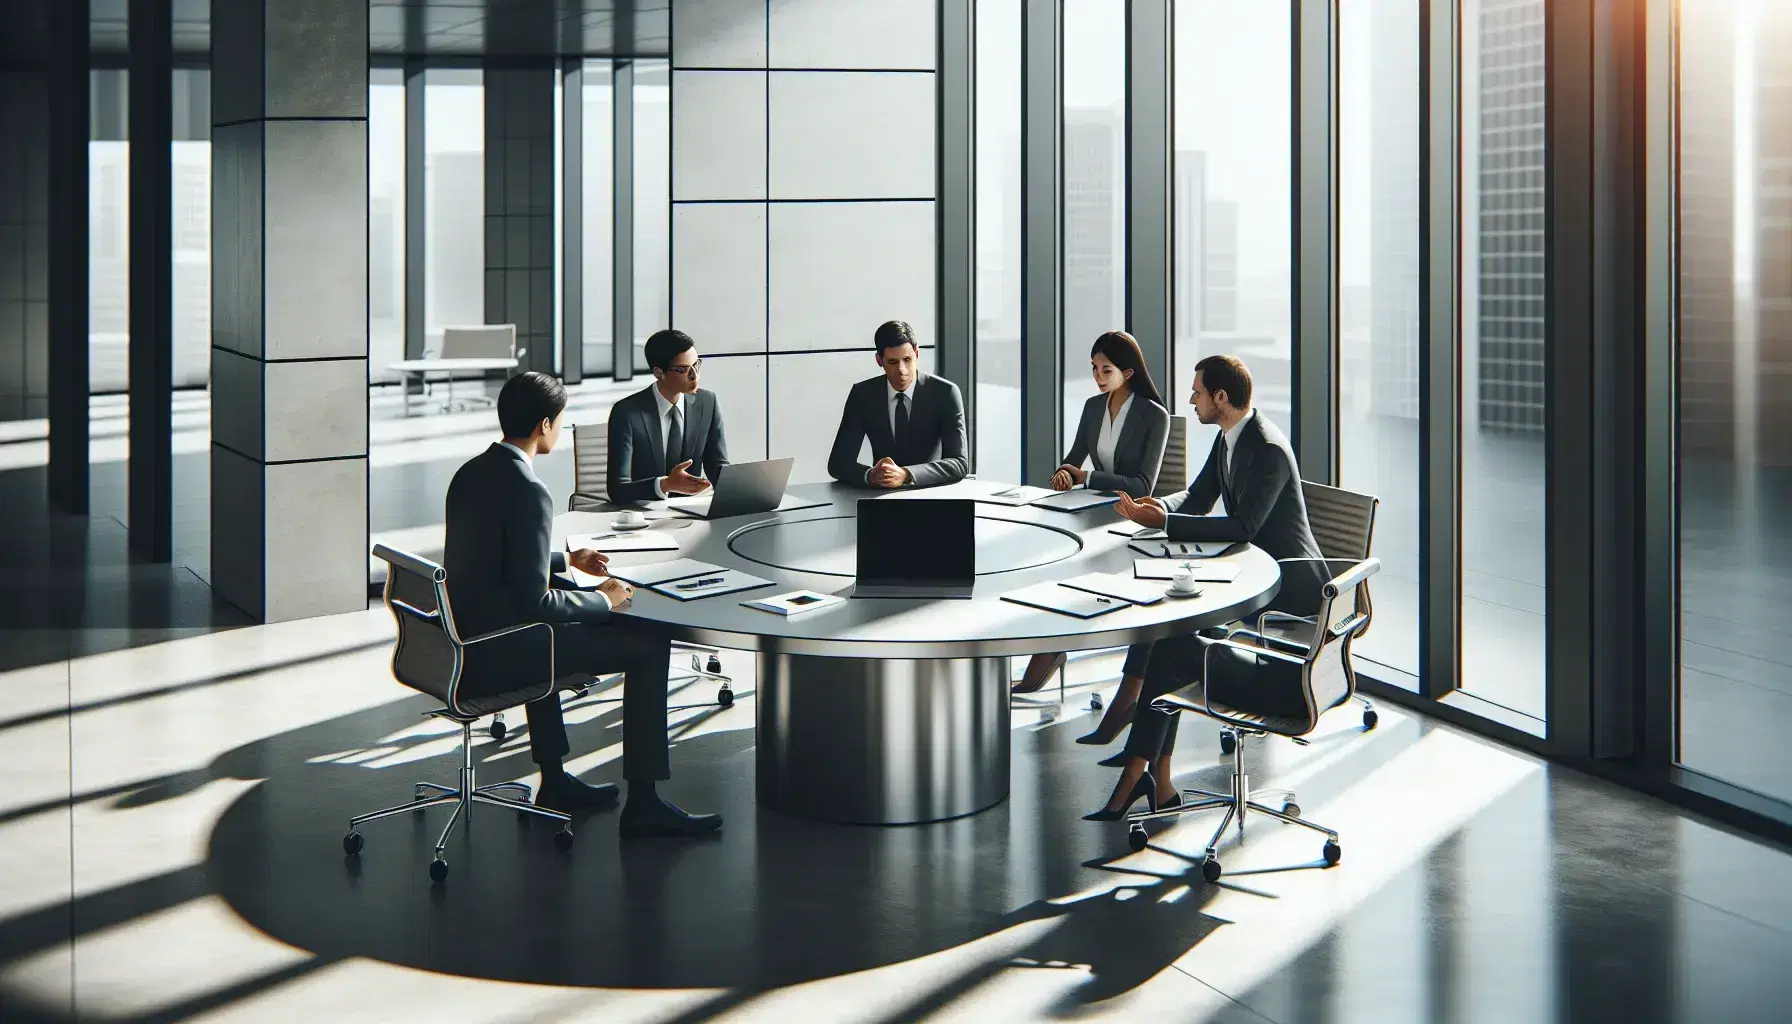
[342,543,572,882]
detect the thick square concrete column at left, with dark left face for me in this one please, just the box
[211,0,367,622]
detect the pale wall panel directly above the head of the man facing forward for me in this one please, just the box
[771,203,935,351]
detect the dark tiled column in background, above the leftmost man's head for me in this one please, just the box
[486,65,559,373]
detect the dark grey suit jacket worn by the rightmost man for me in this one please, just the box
[1163,412,1324,615]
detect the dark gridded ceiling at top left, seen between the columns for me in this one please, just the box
[69,0,672,59]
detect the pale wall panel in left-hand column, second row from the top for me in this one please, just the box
[672,72,765,199]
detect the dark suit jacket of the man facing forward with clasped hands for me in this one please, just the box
[828,373,971,488]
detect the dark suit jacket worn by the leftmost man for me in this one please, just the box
[443,445,609,637]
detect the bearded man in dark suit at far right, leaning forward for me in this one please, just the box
[1091,355,1328,820]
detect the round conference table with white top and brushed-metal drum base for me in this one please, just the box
[554,481,1281,825]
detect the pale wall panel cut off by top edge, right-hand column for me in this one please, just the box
[766,0,937,70]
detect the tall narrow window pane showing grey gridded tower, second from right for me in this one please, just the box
[1459,0,1548,719]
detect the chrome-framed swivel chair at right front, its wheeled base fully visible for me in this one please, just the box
[1127,558,1382,882]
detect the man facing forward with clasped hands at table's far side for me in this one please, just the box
[828,319,971,490]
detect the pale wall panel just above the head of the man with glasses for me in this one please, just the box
[672,203,765,353]
